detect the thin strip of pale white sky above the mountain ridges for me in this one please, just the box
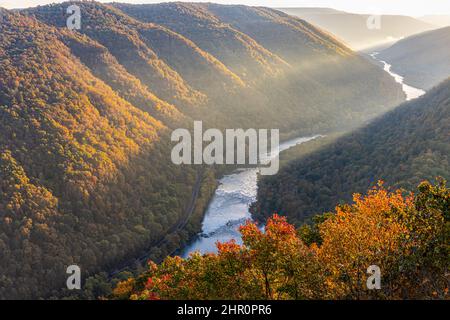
[0,0,450,16]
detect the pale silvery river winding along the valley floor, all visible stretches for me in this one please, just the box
[181,52,425,257]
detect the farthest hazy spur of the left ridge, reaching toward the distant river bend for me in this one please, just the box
[205,4,403,130]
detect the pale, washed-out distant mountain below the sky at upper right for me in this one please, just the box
[278,8,437,50]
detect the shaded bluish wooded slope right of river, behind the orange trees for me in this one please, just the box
[252,80,450,224]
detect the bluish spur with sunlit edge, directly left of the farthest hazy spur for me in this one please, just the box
[113,2,286,81]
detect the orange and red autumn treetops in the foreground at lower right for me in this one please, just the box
[112,180,450,300]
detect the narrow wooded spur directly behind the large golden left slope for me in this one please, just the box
[24,2,212,111]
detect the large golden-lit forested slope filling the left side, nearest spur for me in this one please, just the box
[0,11,203,298]
